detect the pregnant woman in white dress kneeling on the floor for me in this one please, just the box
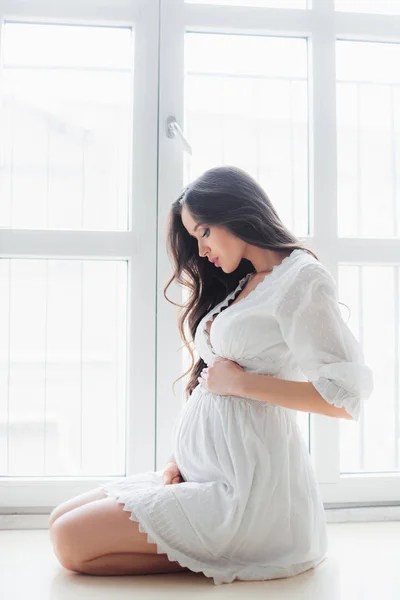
[50,167,373,584]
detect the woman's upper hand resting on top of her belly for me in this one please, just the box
[197,357,244,396]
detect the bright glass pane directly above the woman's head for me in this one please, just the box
[184,33,309,235]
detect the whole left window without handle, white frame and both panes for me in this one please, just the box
[0,0,159,508]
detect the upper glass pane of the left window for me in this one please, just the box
[0,23,133,230]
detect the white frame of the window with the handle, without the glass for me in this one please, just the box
[157,0,400,506]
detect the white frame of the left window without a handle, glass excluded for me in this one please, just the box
[0,0,159,513]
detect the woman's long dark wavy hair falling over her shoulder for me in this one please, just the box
[164,166,346,397]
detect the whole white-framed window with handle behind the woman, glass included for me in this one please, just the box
[158,0,400,504]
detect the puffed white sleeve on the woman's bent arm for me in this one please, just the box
[275,263,374,421]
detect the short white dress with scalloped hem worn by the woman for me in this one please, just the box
[103,250,373,584]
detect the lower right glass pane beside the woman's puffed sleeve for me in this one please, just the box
[338,265,400,473]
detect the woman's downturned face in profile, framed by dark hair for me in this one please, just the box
[181,205,247,273]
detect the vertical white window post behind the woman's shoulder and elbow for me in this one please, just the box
[309,0,340,483]
